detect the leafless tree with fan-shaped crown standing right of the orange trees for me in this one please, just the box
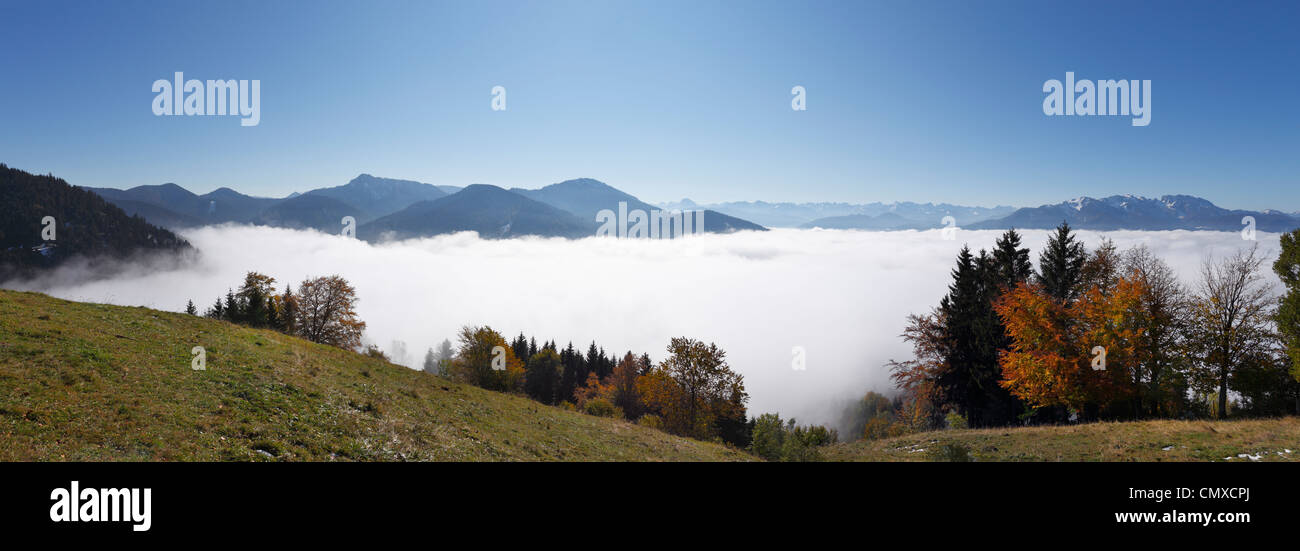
[1188,246,1277,418]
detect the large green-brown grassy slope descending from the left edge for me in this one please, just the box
[0,290,750,460]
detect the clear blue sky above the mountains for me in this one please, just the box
[0,0,1300,211]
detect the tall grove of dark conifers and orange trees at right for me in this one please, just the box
[873,224,1300,437]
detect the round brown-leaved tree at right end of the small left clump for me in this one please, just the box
[294,276,365,350]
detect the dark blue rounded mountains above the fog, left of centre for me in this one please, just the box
[87,174,766,240]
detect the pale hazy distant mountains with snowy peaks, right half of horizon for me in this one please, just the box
[663,195,1300,231]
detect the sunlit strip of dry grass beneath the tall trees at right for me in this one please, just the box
[826,417,1300,461]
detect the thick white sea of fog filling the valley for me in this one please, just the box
[4,226,1278,422]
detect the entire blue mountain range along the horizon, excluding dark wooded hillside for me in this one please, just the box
[65,174,1300,240]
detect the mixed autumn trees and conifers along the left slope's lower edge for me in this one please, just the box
[186,272,837,461]
